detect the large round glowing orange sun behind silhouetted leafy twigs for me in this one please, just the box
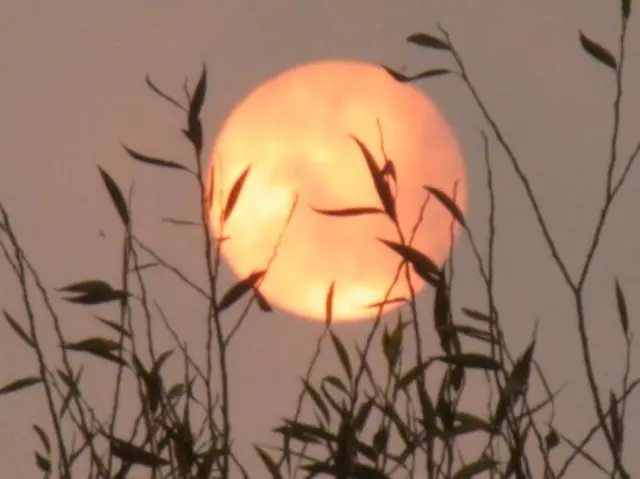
[210,61,467,321]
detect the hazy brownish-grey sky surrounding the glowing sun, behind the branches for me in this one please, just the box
[0,0,640,477]
